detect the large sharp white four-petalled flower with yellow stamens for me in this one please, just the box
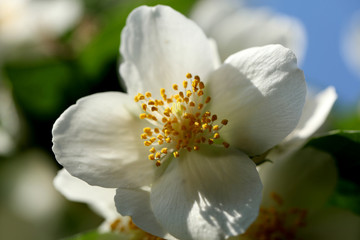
[53,6,306,239]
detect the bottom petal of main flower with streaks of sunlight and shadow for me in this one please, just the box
[151,146,262,239]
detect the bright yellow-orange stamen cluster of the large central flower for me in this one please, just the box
[134,73,229,166]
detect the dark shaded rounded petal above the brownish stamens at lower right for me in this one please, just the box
[259,148,337,211]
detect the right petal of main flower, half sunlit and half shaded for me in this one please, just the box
[207,45,306,155]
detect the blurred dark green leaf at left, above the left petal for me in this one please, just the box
[5,59,72,118]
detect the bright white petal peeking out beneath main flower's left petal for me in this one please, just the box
[54,168,119,219]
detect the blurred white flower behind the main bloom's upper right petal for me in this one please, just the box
[191,0,306,63]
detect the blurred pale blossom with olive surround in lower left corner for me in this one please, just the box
[0,149,64,240]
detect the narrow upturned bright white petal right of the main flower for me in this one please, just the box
[283,87,337,144]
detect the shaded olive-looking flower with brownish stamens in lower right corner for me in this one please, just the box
[234,148,360,240]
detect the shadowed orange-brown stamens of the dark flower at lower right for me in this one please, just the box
[241,192,307,240]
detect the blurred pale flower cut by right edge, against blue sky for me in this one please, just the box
[341,10,360,78]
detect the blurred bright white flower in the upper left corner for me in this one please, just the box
[0,0,82,58]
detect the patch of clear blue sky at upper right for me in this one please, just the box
[249,0,360,105]
